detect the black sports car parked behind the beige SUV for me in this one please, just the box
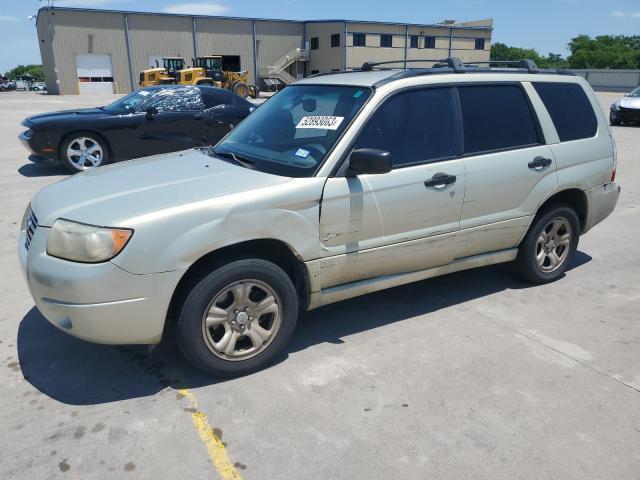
[20,85,255,172]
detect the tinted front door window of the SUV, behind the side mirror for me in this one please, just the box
[355,88,461,167]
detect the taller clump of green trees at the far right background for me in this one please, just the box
[568,35,640,69]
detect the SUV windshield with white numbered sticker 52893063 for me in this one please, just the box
[215,85,371,177]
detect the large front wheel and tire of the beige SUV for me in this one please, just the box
[177,259,298,377]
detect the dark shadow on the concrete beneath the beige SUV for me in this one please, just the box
[17,252,591,405]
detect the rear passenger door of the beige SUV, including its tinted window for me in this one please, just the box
[456,83,558,257]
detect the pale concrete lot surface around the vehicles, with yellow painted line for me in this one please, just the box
[0,92,640,480]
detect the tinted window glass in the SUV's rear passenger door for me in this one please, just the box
[458,85,539,154]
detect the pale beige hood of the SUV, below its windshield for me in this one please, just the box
[31,150,291,227]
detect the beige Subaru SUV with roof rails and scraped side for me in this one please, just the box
[19,59,620,376]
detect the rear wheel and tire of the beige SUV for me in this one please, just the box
[514,204,580,284]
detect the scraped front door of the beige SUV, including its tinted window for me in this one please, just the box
[320,88,466,288]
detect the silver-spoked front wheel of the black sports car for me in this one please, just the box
[60,131,109,173]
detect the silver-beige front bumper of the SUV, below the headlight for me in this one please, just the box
[19,226,184,344]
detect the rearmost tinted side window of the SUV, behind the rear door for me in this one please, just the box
[533,82,598,142]
